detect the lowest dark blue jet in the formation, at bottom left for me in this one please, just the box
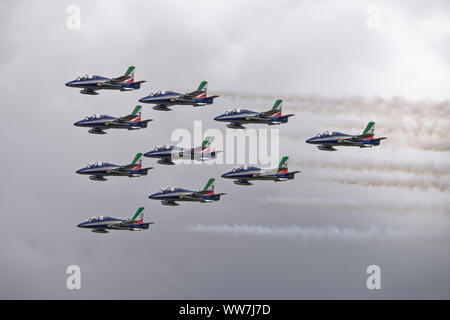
[77,207,154,233]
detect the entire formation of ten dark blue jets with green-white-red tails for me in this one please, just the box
[66,66,387,233]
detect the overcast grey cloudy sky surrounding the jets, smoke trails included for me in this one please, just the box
[0,1,450,299]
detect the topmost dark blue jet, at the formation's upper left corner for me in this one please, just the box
[66,66,145,95]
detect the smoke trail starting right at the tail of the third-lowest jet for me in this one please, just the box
[291,159,450,177]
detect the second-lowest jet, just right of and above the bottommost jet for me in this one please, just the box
[149,178,225,206]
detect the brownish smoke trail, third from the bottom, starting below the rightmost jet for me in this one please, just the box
[323,177,450,192]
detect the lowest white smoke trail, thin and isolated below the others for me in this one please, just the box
[186,224,412,241]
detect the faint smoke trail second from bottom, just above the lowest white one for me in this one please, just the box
[260,196,450,214]
